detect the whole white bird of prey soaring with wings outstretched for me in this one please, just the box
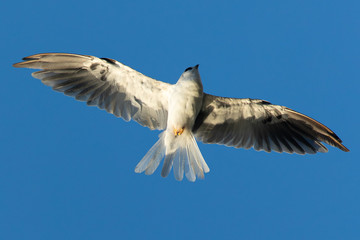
[13,53,349,182]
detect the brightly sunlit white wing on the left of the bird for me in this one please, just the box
[14,53,171,129]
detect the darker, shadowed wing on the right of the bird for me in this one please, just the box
[193,94,349,154]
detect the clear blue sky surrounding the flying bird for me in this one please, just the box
[0,0,360,240]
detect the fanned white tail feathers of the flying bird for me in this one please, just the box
[135,131,210,182]
